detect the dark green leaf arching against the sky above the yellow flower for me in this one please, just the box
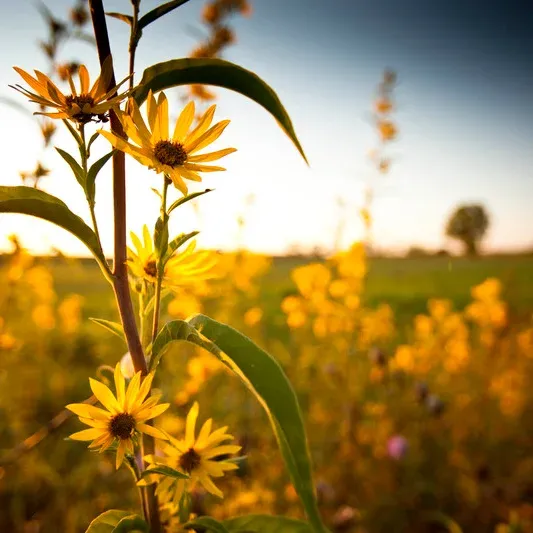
[134,58,307,163]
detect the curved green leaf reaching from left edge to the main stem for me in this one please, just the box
[0,186,107,267]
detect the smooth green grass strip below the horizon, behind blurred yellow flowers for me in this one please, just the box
[44,255,533,323]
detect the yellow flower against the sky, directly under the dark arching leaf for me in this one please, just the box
[100,91,236,194]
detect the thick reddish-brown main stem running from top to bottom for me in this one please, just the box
[89,0,161,533]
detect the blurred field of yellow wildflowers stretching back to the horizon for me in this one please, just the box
[0,244,533,532]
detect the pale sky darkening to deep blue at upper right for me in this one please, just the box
[0,0,533,253]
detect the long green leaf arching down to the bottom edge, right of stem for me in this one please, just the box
[149,315,326,533]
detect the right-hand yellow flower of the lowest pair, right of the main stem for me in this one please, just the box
[145,402,241,504]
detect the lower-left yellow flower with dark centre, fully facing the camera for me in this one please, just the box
[67,363,170,469]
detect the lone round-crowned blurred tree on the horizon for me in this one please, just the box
[446,204,489,255]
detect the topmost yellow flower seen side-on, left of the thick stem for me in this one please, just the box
[11,56,130,124]
